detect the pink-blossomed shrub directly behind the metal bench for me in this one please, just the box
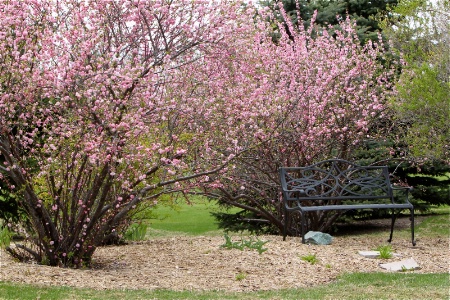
[192,8,395,235]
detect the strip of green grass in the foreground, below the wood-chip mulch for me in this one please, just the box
[0,273,449,300]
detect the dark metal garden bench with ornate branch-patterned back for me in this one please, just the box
[280,159,416,246]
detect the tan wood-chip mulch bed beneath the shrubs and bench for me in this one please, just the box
[0,217,449,291]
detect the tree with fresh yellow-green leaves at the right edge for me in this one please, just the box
[384,0,450,162]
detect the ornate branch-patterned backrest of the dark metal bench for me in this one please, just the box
[280,159,393,201]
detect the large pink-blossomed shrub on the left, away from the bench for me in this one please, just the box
[0,0,253,267]
